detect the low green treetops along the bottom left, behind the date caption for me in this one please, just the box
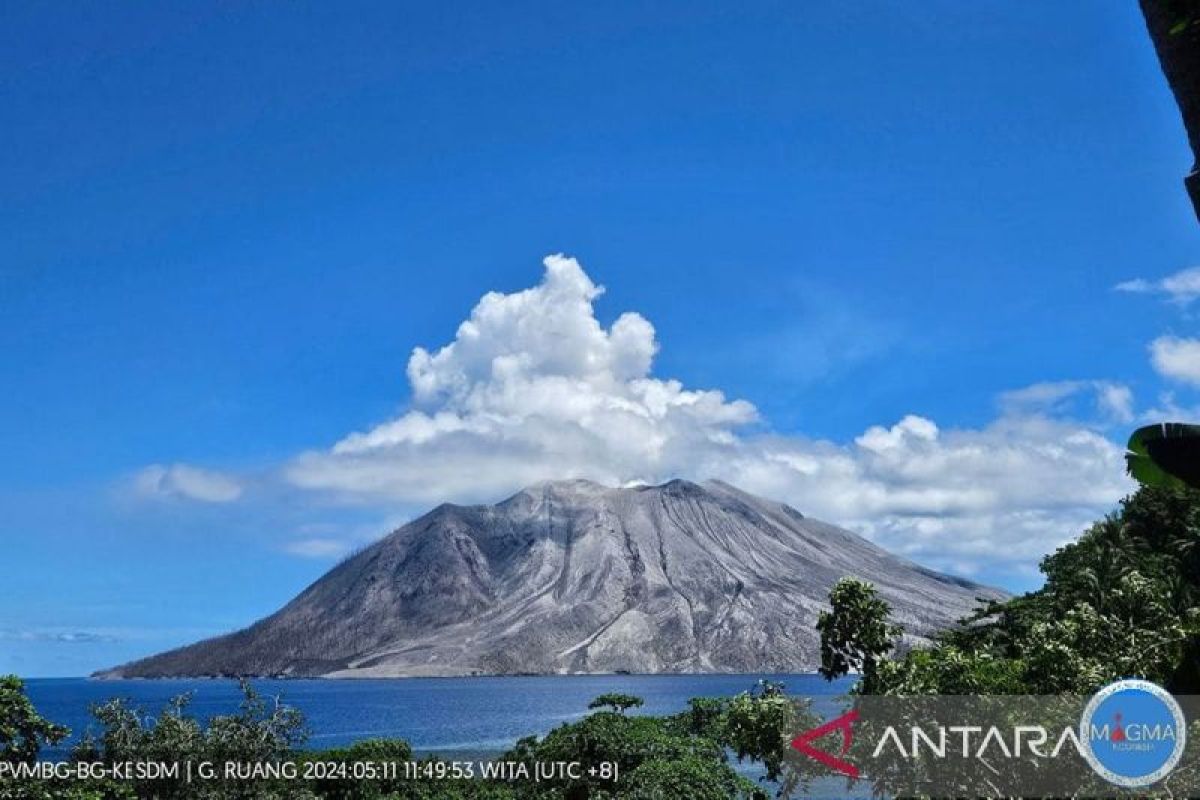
[0,678,806,800]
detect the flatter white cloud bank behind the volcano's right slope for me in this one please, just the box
[724,415,1130,571]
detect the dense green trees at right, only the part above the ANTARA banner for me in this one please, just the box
[821,483,1200,694]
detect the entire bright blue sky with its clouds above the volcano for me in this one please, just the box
[0,0,1200,675]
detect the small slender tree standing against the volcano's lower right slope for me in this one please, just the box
[817,578,901,694]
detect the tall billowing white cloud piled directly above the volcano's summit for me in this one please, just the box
[288,255,757,503]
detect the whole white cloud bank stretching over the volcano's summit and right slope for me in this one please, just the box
[287,255,1132,570]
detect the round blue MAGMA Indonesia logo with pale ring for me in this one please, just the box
[1079,679,1188,788]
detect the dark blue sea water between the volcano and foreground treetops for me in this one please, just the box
[25,674,853,758]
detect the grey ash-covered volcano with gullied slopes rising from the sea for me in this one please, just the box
[98,481,1003,678]
